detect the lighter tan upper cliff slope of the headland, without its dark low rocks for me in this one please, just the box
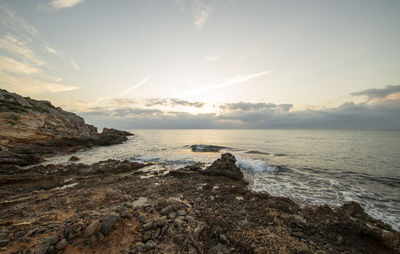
[0,89,97,150]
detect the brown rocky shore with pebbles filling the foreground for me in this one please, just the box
[0,153,400,254]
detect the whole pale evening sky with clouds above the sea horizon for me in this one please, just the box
[0,0,400,129]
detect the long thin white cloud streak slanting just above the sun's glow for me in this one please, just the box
[185,71,272,97]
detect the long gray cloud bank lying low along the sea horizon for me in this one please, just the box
[80,86,400,129]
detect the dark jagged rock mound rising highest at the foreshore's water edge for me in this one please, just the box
[203,153,244,181]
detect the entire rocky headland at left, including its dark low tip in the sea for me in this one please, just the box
[0,89,133,169]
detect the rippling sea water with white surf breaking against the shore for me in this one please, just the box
[39,130,400,230]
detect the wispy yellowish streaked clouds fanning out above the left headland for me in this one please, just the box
[0,3,79,95]
